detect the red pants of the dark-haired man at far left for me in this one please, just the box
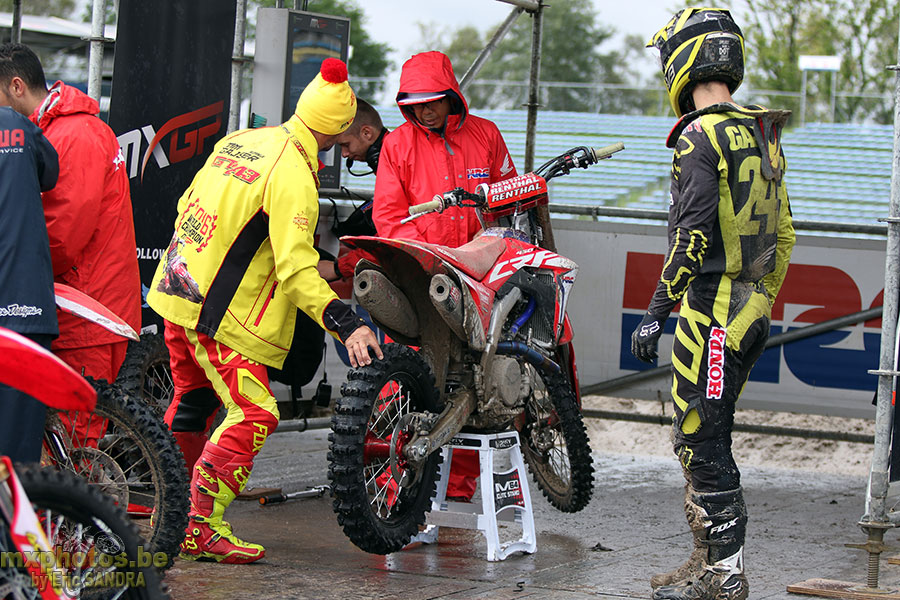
[53,340,128,448]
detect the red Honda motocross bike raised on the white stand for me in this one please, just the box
[329,144,624,554]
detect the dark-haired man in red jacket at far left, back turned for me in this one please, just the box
[0,44,141,439]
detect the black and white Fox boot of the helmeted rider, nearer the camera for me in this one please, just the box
[653,488,750,600]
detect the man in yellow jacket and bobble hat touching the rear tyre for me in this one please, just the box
[147,58,382,563]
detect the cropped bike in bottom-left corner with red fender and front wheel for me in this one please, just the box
[0,327,169,600]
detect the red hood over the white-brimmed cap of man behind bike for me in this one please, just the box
[397,51,469,132]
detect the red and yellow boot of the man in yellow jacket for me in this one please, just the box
[180,442,266,564]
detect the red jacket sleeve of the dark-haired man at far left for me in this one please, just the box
[42,116,110,276]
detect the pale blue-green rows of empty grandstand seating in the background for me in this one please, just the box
[342,106,893,229]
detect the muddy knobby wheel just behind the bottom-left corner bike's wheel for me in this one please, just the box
[44,380,190,564]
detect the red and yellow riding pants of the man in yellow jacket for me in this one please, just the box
[165,322,279,456]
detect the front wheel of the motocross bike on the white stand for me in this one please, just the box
[518,366,594,512]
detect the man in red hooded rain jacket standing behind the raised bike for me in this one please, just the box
[372,51,517,500]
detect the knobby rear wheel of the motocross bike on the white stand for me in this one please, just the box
[328,344,441,554]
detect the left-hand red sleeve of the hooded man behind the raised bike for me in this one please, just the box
[372,135,422,240]
